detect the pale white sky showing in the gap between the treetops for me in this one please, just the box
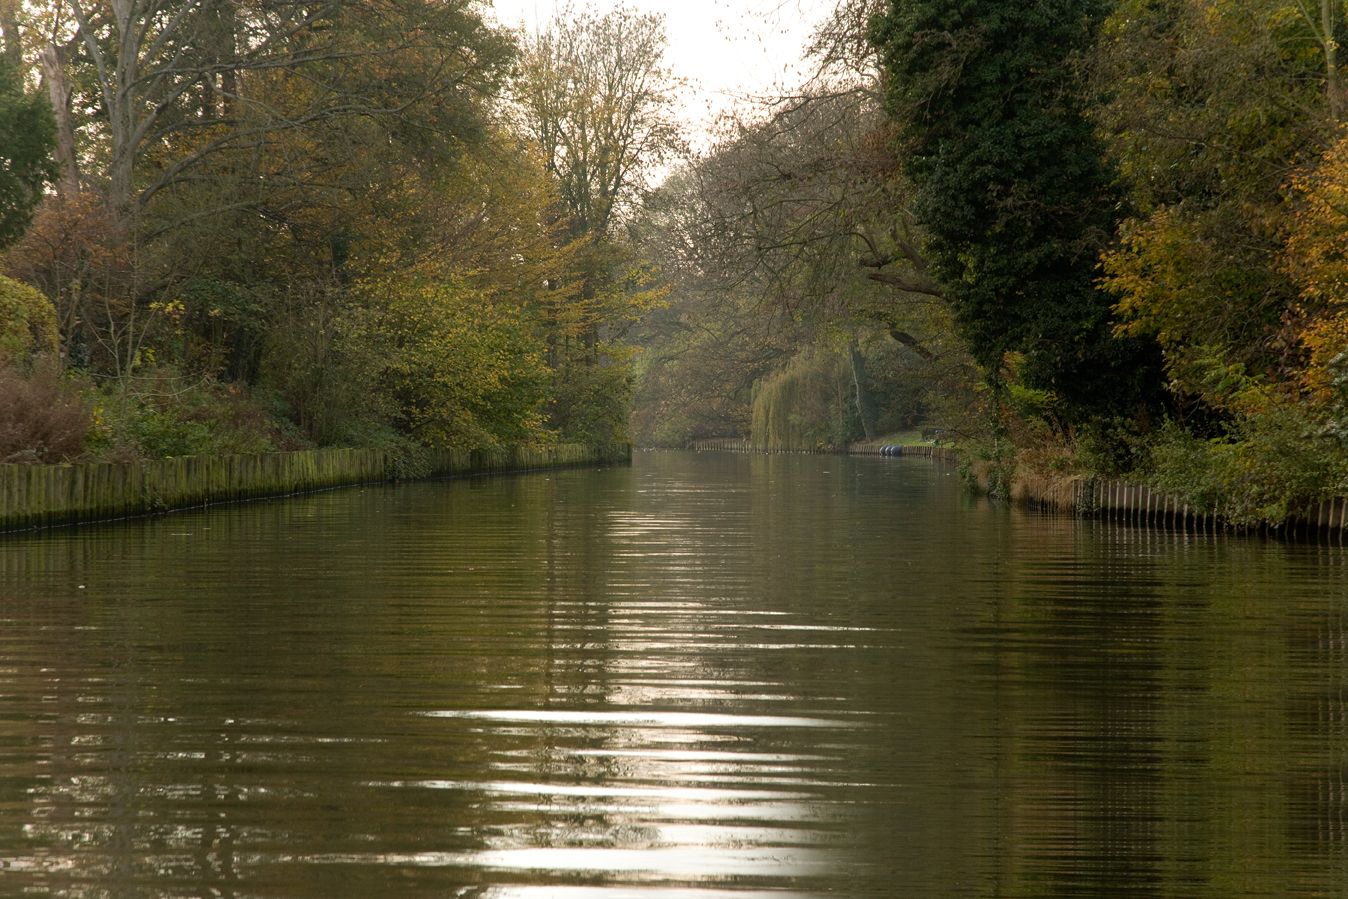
[489,0,834,147]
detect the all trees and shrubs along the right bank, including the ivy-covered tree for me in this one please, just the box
[636,0,1348,524]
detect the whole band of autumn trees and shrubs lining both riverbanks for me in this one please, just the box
[0,0,1348,524]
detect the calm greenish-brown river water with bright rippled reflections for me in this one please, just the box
[0,453,1348,899]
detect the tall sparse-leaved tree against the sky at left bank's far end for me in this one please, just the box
[514,7,682,441]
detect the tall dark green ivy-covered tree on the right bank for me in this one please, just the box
[872,0,1159,425]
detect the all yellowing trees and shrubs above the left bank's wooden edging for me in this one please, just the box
[0,0,679,469]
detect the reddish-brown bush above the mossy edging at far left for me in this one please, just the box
[0,360,93,462]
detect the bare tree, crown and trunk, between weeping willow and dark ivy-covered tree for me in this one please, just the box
[649,91,958,437]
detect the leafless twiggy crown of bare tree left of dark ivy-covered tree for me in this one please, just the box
[690,90,941,330]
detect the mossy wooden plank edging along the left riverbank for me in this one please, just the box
[0,443,632,532]
